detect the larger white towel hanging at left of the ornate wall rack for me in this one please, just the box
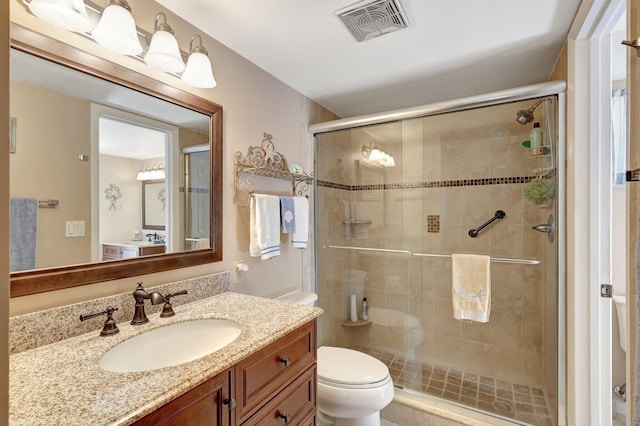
[249,194,280,260]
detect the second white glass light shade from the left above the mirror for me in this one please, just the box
[91,4,142,55]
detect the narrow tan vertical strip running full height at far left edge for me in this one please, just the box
[0,2,9,426]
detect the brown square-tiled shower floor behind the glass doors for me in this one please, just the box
[355,347,553,426]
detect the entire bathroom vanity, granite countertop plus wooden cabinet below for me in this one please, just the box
[9,292,322,426]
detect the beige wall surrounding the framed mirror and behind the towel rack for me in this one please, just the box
[10,0,336,315]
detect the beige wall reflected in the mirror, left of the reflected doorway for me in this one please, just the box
[9,81,91,268]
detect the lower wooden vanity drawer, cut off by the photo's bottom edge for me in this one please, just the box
[243,366,316,426]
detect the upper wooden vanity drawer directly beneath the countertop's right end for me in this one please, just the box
[236,319,316,423]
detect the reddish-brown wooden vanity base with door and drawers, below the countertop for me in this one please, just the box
[134,319,316,426]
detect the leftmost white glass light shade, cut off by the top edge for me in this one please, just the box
[29,0,94,33]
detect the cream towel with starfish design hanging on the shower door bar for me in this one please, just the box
[451,253,491,322]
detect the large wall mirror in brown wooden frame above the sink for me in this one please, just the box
[10,23,222,297]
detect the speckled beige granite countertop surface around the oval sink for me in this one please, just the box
[9,292,323,426]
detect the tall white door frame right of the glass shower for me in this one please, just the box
[566,0,626,425]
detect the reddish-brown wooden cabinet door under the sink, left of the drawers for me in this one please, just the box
[134,369,235,426]
